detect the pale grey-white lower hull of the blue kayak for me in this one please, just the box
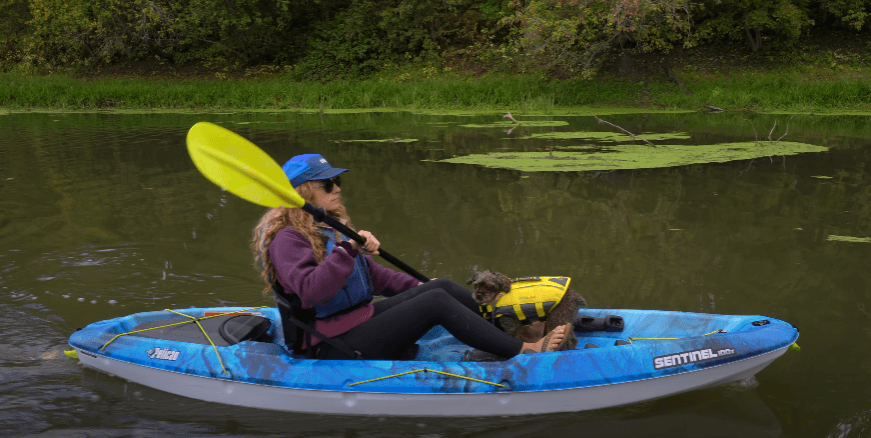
[76,347,788,417]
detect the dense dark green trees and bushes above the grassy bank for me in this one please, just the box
[0,0,871,81]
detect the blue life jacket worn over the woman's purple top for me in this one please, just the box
[314,228,375,319]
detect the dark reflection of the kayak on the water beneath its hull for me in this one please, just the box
[76,370,783,438]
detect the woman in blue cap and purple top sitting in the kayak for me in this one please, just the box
[251,154,569,360]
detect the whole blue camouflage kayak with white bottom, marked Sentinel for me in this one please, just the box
[69,307,799,416]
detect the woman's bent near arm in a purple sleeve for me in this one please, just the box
[269,227,354,309]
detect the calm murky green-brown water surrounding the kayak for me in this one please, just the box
[0,109,871,438]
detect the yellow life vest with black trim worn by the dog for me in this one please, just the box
[480,277,572,325]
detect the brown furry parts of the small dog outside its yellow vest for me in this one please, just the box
[466,270,587,350]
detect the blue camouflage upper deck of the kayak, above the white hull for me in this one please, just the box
[70,308,798,393]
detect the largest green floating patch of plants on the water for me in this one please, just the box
[441,141,828,172]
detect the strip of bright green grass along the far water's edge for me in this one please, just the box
[0,71,871,114]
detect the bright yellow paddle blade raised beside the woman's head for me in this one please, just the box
[187,122,305,208]
